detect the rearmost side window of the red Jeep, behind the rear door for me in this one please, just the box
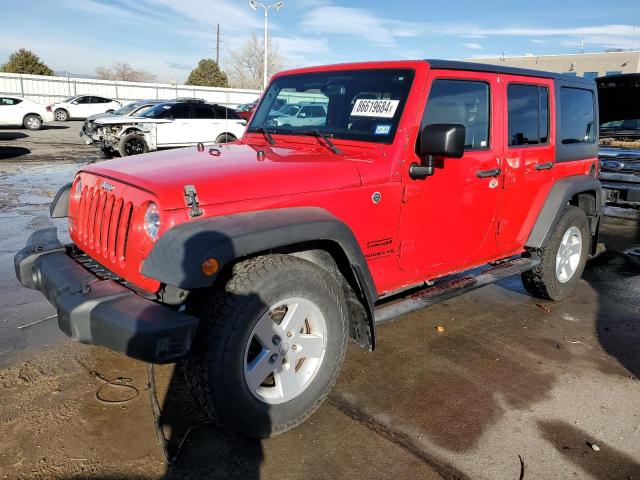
[560,87,596,145]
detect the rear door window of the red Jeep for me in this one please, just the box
[507,84,549,147]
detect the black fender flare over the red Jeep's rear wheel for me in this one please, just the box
[525,175,604,254]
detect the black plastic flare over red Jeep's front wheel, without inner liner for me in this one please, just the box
[142,207,377,312]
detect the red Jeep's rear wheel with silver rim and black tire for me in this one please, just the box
[522,205,591,300]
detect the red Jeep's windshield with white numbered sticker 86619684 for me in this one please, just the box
[248,69,414,143]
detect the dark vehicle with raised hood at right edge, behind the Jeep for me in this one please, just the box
[596,73,640,208]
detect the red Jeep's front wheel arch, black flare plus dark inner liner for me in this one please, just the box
[142,207,377,349]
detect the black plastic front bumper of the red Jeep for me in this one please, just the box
[14,228,198,363]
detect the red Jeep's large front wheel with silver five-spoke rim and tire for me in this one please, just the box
[185,255,348,438]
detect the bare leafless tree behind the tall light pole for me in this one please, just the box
[225,33,287,89]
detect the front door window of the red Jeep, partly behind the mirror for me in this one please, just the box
[422,79,489,149]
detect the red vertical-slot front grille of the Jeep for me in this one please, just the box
[77,187,133,267]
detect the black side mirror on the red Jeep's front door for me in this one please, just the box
[409,123,466,179]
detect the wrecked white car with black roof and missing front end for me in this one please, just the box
[89,99,247,157]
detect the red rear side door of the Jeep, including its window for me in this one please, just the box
[496,75,555,247]
